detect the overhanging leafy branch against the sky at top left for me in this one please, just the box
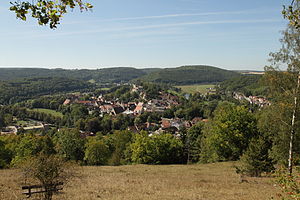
[10,0,93,29]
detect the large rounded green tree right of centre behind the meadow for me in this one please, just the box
[201,103,258,162]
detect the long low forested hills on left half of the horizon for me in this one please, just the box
[0,67,147,83]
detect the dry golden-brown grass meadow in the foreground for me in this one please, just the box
[0,162,278,200]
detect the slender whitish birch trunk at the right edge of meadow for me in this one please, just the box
[288,72,300,175]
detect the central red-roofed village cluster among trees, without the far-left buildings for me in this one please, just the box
[63,84,208,136]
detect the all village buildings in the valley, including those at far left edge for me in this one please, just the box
[1,84,208,137]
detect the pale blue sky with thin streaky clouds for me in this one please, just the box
[0,0,289,70]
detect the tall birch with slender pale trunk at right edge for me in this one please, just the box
[265,26,300,174]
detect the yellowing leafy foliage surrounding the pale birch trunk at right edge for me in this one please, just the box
[264,26,300,169]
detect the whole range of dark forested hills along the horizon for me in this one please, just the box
[0,65,239,85]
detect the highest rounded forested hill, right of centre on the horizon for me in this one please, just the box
[141,65,239,85]
